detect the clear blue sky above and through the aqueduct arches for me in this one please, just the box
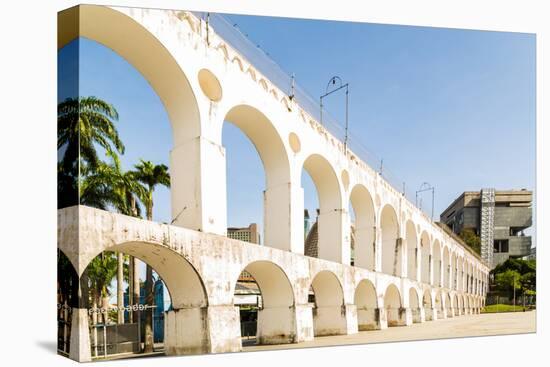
[58,11,535,240]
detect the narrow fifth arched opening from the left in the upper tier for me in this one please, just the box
[380,204,403,276]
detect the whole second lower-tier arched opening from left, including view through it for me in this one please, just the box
[234,261,296,345]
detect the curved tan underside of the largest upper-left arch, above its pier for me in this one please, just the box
[57,5,200,146]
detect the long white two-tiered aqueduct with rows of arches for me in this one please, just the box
[58,5,489,361]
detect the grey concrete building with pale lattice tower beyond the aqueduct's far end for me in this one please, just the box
[440,189,533,268]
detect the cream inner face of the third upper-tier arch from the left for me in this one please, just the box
[302,154,344,264]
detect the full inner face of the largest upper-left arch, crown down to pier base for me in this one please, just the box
[58,5,204,230]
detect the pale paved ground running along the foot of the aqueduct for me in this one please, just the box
[243,311,536,351]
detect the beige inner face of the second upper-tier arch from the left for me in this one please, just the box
[224,104,291,250]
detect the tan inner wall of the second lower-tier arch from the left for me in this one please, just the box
[233,260,296,344]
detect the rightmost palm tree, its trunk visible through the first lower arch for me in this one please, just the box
[134,159,170,353]
